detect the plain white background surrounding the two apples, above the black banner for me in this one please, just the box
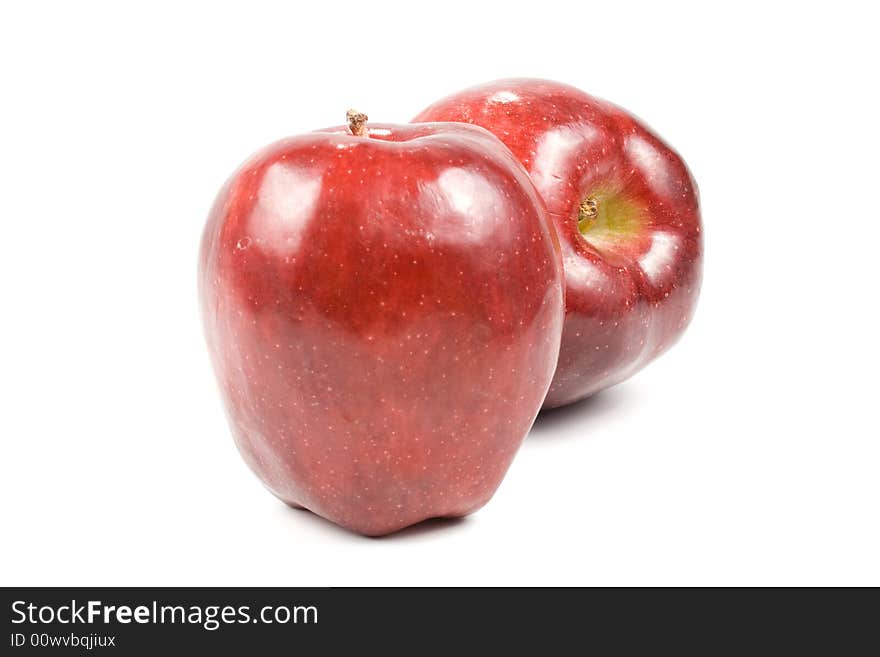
[0,0,880,585]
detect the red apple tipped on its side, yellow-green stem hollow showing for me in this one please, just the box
[414,79,703,408]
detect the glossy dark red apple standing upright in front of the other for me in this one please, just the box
[199,123,564,535]
